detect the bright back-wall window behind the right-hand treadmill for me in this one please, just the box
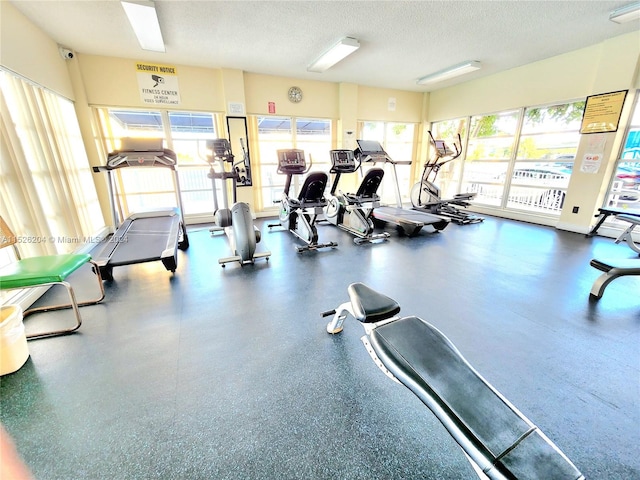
[358,122,415,204]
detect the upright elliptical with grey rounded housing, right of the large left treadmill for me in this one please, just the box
[207,138,271,267]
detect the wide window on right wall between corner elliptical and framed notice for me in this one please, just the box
[461,101,584,215]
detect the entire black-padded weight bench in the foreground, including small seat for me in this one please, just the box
[322,283,584,480]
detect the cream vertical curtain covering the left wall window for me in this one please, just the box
[0,70,105,256]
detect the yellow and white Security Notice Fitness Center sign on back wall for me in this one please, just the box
[136,62,180,105]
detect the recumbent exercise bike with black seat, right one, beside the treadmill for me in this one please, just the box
[324,150,390,245]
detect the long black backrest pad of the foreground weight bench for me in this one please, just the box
[370,317,580,480]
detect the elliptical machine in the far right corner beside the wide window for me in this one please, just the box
[411,131,484,225]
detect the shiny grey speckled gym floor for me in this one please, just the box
[0,218,640,480]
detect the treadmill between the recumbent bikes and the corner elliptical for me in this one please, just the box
[354,140,449,237]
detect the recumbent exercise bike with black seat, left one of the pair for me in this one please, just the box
[269,149,338,253]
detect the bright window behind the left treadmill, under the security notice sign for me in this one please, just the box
[98,108,221,218]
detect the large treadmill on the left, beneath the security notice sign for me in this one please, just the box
[91,138,189,280]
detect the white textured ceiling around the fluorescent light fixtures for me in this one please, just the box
[3,0,640,91]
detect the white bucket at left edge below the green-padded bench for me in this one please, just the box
[0,305,29,375]
